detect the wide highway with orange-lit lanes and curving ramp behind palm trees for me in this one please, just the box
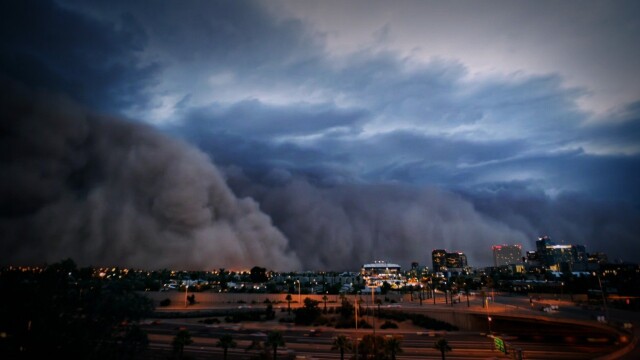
[136,296,631,360]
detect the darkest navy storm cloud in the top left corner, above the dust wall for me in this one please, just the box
[0,0,159,111]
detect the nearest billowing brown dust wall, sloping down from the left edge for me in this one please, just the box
[0,79,300,270]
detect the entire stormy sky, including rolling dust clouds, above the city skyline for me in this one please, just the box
[0,0,640,270]
